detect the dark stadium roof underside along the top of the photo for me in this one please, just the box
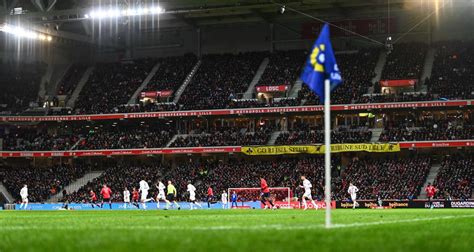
[0,0,410,47]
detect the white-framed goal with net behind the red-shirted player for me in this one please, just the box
[227,187,293,208]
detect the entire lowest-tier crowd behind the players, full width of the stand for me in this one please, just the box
[0,155,474,202]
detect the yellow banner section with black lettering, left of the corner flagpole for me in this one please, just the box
[241,145,318,156]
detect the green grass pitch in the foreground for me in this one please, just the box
[0,209,474,252]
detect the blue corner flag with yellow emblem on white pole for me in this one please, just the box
[301,24,342,103]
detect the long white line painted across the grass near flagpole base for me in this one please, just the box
[0,215,474,232]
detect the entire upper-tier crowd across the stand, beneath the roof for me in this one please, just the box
[4,41,474,114]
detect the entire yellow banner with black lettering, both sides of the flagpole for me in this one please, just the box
[241,143,400,156]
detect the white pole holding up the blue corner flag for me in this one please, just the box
[324,79,331,228]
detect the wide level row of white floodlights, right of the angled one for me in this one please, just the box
[84,6,165,19]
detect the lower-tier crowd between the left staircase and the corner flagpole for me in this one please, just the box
[63,157,323,202]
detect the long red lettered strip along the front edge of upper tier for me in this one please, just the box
[0,100,474,122]
